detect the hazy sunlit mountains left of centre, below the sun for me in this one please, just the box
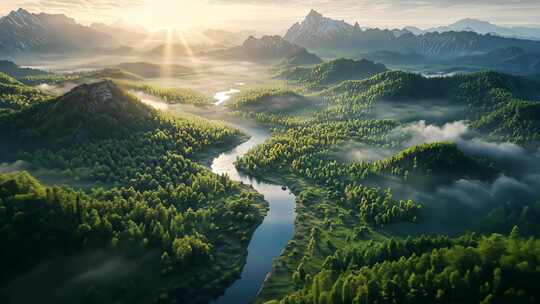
[0,8,255,55]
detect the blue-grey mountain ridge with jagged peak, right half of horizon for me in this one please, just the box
[284,11,540,57]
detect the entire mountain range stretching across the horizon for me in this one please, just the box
[0,9,540,60]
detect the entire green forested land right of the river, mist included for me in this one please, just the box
[233,69,540,304]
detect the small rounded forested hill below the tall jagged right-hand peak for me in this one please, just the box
[279,58,387,88]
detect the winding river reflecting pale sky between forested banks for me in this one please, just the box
[211,94,296,304]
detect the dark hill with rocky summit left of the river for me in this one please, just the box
[0,81,158,148]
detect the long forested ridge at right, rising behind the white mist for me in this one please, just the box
[320,71,540,147]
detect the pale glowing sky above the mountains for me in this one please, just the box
[0,0,540,34]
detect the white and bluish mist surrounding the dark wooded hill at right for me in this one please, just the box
[334,121,540,234]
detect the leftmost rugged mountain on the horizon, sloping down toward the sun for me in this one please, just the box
[0,9,116,53]
